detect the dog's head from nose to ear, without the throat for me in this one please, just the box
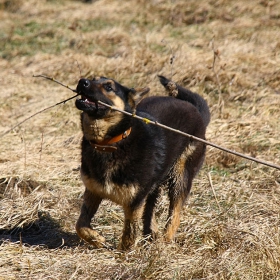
[76,77,149,119]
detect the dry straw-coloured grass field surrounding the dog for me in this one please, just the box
[0,0,280,280]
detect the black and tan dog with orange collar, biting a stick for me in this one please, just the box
[76,76,210,249]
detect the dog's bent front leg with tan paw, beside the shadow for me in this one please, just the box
[76,189,105,248]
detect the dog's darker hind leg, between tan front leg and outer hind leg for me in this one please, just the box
[143,187,160,239]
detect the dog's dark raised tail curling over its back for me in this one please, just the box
[158,76,210,126]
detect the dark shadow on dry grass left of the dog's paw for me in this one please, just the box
[0,212,82,249]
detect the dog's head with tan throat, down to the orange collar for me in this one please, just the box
[76,77,149,143]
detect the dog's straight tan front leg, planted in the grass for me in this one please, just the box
[119,206,143,250]
